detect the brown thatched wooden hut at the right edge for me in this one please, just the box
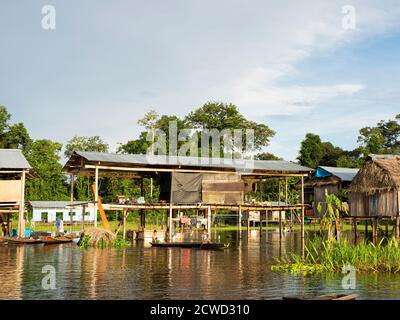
[349,155,400,217]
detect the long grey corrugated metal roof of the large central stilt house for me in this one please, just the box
[75,151,312,173]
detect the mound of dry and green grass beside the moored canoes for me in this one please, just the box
[78,228,130,249]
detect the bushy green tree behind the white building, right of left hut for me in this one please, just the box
[26,139,68,200]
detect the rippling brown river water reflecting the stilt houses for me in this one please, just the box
[0,231,400,299]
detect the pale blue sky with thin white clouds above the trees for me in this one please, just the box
[0,0,400,160]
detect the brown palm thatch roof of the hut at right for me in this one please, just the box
[349,155,400,194]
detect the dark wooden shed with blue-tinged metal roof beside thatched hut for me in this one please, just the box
[304,166,359,215]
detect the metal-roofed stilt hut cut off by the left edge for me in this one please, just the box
[0,149,32,236]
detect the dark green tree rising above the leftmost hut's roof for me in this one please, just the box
[0,106,32,150]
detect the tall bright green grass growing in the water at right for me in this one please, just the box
[272,238,400,274]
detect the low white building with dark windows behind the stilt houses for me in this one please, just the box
[30,201,95,223]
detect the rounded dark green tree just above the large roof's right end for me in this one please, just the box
[297,133,324,168]
